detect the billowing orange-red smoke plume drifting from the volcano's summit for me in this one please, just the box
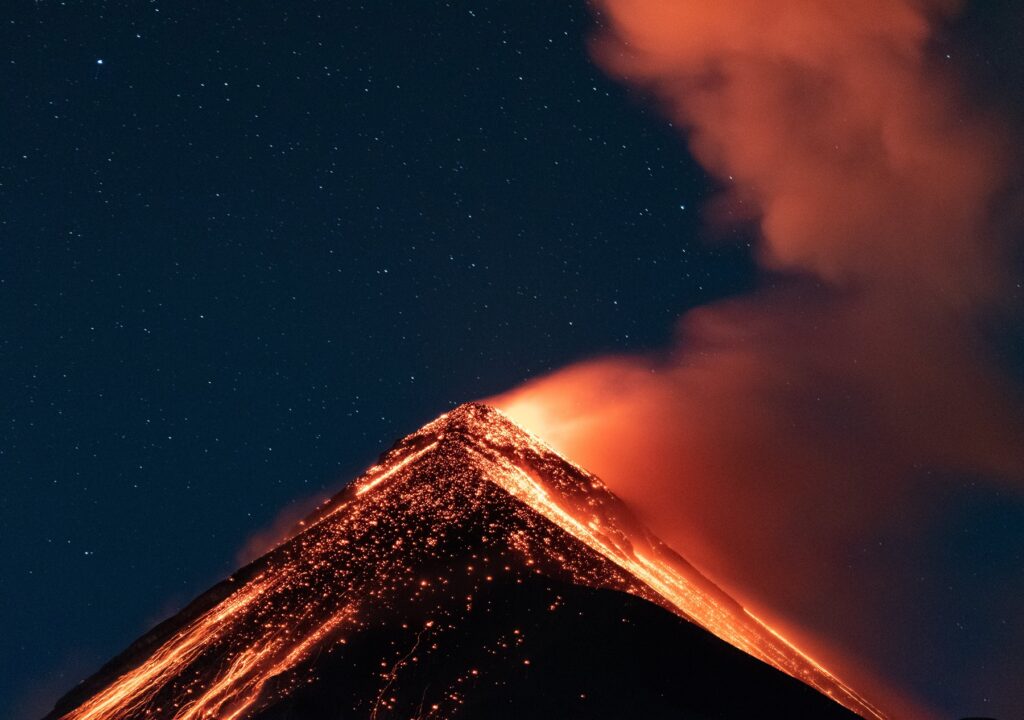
[490,0,1024,712]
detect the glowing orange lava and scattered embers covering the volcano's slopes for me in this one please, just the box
[49,404,884,720]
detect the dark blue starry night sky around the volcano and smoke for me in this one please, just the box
[0,0,1024,718]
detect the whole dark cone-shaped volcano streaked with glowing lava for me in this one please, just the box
[47,404,885,720]
